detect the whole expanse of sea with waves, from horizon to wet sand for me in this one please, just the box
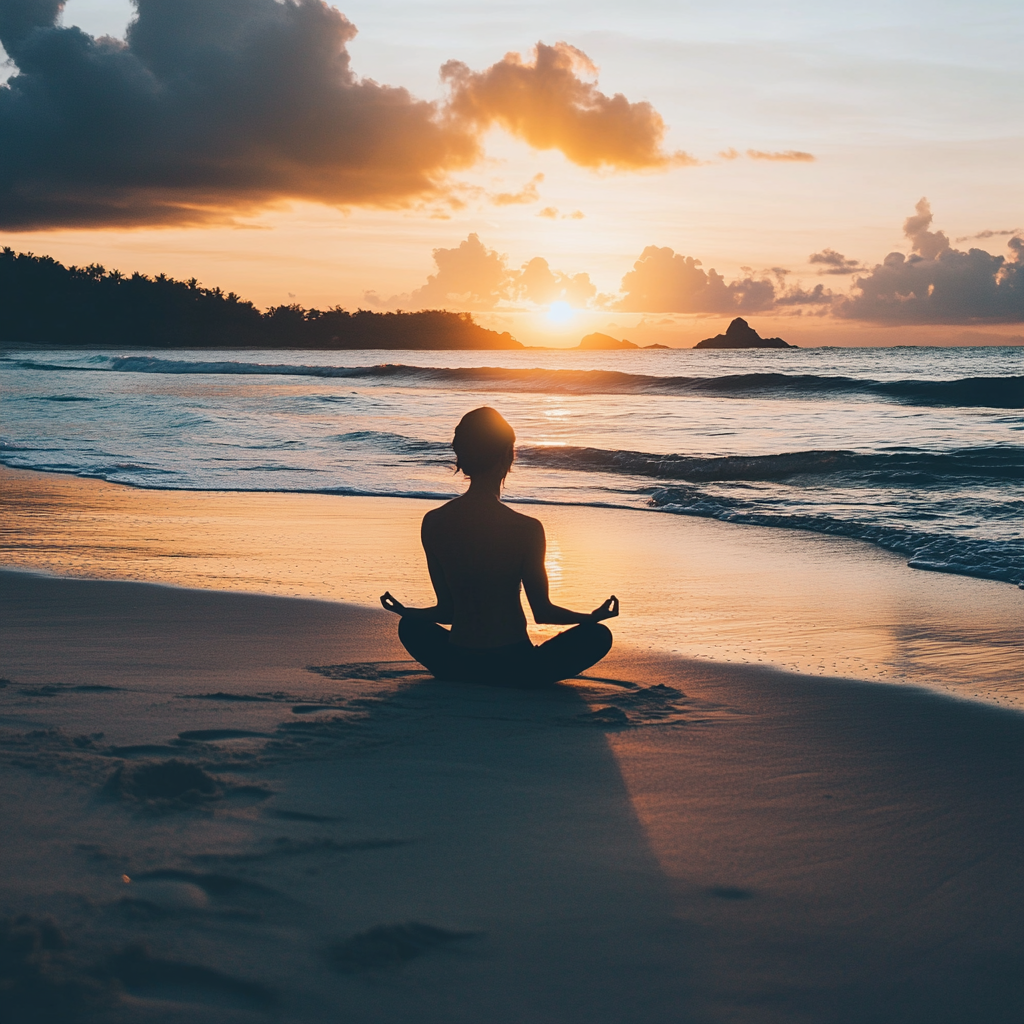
[0,347,1024,587]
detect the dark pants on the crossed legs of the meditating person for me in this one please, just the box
[398,616,611,686]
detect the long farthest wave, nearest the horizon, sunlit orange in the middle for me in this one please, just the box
[5,355,1024,409]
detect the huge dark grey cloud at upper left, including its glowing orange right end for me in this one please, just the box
[0,0,688,229]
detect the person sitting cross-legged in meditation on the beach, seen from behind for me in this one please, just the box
[381,407,618,686]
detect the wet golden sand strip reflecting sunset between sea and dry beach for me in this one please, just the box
[0,467,1024,708]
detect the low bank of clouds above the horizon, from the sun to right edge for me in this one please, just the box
[391,199,1024,325]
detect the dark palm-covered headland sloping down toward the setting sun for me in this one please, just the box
[0,248,522,349]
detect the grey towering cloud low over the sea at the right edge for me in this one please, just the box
[834,199,1024,324]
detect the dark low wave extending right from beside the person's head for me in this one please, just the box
[517,445,1024,486]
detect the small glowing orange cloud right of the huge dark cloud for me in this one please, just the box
[441,43,695,170]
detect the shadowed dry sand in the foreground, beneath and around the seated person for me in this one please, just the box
[0,474,1024,1024]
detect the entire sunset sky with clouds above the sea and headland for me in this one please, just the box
[0,0,1024,345]
